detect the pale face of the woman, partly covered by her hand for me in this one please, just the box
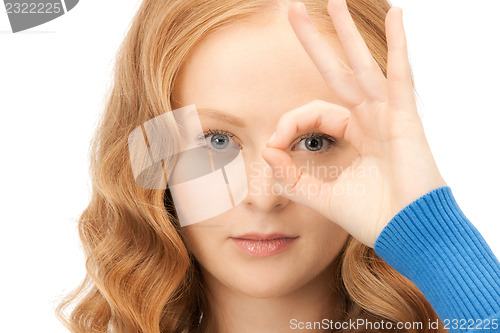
[172,13,357,297]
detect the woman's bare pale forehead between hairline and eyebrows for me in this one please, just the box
[173,13,346,121]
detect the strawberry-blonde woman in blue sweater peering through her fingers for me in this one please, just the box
[58,0,500,332]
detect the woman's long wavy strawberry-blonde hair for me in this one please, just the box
[55,0,446,333]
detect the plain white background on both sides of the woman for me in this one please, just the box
[0,0,500,333]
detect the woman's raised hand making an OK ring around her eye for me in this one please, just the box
[262,0,446,247]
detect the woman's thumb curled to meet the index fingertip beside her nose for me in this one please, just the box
[262,147,334,216]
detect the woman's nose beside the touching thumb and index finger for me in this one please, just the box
[243,156,290,213]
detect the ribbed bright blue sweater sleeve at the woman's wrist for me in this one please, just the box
[374,186,500,333]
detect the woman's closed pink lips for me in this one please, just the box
[231,233,299,257]
